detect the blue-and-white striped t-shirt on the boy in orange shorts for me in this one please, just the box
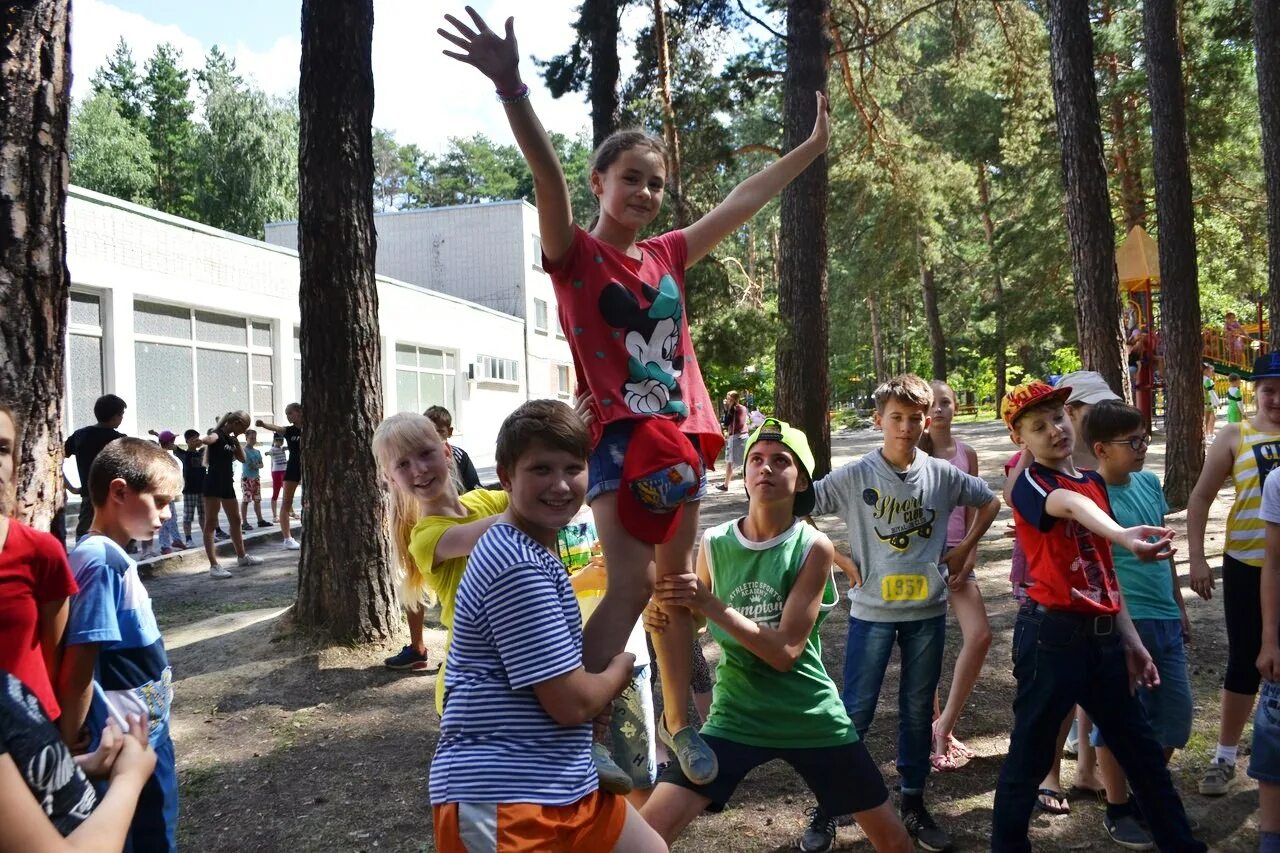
[430,523,596,806]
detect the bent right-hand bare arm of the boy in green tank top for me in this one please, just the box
[657,537,836,672]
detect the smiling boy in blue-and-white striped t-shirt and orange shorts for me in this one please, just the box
[430,400,667,853]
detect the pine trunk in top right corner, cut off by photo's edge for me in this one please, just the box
[1253,0,1280,352]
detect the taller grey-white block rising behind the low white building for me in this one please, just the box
[266,201,573,400]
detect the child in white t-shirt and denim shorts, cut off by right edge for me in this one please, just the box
[1249,458,1280,853]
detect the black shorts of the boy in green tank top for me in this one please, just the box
[658,735,888,816]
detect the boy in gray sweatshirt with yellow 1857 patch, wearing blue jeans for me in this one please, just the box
[814,374,1000,850]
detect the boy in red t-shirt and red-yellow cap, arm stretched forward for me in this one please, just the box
[991,382,1208,852]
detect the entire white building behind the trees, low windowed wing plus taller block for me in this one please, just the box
[67,187,558,469]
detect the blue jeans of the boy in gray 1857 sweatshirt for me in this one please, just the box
[845,615,942,794]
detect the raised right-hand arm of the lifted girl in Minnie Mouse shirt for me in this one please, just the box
[685,92,831,269]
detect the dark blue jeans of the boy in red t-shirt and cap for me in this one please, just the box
[991,602,1208,853]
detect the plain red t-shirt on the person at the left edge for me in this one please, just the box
[0,519,78,720]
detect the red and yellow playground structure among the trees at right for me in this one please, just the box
[1116,225,1268,424]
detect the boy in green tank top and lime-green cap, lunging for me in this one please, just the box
[640,418,911,852]
